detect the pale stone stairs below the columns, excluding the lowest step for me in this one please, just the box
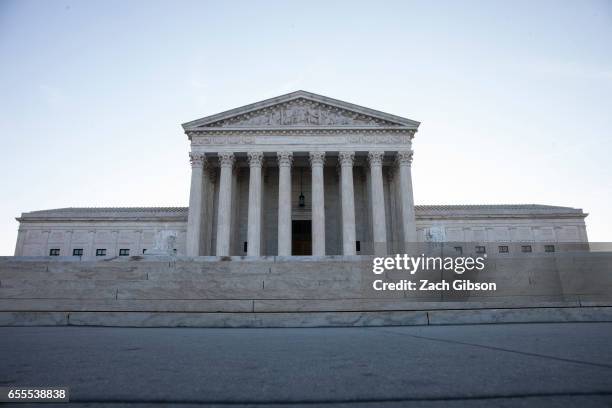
[0,252,612,312]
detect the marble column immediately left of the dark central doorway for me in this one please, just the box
[277,152,293,256]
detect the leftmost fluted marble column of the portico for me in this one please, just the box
[186,152,206,256]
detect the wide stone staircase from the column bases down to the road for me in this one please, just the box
[0,257,612,327]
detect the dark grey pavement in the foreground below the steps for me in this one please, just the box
[0,323,612,407]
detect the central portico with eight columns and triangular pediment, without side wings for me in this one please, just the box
[183,91,419,256]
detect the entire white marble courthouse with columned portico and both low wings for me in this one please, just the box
[15,91,588,258]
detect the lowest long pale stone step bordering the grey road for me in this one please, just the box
[0,307,612,327]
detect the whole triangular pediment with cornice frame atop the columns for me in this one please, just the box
[183,91,419,131]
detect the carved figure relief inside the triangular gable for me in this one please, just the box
[197,98,400,127]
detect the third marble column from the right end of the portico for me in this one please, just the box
[338,152,356,255]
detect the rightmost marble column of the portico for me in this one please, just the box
[396,150,417,251]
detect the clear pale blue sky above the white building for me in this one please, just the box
[0,0,612,255]
